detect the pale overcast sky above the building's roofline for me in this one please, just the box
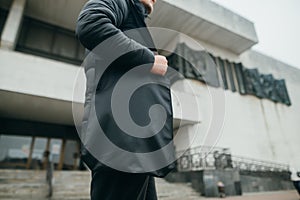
[213,0,300,68]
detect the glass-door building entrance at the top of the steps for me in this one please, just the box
[0,135,79,170]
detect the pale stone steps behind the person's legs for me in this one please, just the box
[0,170,203,200]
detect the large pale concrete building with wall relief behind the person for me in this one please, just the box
[0,0,300,195]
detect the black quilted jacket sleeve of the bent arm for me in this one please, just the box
[76,0,154,63]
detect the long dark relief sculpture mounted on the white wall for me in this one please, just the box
[167,43,291,105]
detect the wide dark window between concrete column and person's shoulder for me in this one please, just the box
[16,17,84,65]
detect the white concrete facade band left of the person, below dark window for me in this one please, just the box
[0,49,79,101]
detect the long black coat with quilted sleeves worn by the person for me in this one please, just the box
[76,0,174,176]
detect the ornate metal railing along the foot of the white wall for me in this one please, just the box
[177,146,289,172]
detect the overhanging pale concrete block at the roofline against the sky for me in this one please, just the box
[148,0,258,54]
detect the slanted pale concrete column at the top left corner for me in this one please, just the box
[0,0,26,50]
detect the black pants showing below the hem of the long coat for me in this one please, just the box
[91,171,157,200]
